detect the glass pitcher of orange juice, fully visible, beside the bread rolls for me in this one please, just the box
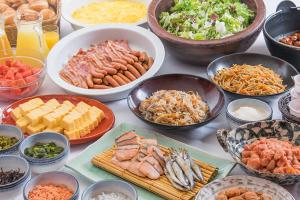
[15,11,49,60]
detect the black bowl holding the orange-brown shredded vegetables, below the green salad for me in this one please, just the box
[207,53,298,101]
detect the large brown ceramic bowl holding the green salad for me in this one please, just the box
[148,0,266,66]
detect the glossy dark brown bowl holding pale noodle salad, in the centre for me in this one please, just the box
[127,74,225,130]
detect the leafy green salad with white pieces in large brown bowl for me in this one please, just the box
[159,0,255,40]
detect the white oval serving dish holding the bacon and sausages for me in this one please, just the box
[47,24,165,101]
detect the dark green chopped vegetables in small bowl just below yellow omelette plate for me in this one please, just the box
[24,142,64,159]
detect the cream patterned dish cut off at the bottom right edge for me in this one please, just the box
[196,175,295,200]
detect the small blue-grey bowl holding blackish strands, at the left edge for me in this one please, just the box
[0,155,31,199]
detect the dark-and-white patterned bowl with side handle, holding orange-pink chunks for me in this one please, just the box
[217,120,300,185]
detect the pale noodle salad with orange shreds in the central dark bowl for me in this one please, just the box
[139,90,209,126]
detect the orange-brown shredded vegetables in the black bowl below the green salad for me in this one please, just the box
[213,64,286,96]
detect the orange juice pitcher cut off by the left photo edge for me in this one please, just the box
[0,15,13,58]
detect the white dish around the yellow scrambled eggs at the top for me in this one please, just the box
[62,0,151,30]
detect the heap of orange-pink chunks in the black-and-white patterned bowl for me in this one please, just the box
[242,138,300,174]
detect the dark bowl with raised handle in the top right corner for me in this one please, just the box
[263,1,300,70]
